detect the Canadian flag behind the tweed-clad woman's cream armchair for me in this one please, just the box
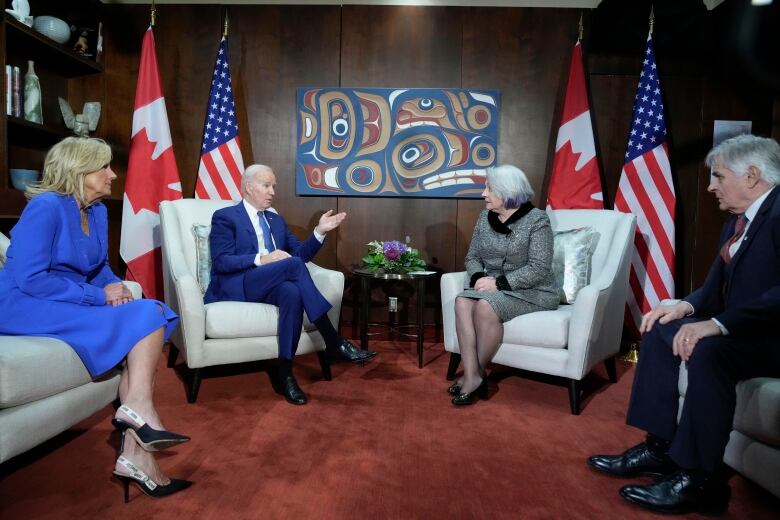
[547,40,604,209]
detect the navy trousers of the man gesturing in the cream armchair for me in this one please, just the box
[244,257,331,360]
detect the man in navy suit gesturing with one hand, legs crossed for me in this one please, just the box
[204,164,376,404]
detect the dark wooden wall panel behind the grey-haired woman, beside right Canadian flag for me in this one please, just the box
[464,7,579,269]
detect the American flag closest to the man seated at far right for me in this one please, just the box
[615,33,675,332]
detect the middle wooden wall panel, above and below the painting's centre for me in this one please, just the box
[339,6,462,271]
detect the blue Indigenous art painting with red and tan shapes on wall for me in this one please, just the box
[295,88,499,198]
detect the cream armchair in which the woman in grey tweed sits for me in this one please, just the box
[441,210,635,415]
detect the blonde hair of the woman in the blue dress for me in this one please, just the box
[25,137,111,208]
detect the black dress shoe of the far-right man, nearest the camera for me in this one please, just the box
[620,470,731,515]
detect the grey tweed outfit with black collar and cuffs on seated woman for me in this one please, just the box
[458,203,560,323]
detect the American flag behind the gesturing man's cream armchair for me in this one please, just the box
[195,36,244,200]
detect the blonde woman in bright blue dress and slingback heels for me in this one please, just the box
[0,137,190,500]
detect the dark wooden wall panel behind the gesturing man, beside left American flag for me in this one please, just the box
[230,6,344,269]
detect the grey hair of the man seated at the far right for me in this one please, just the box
[704,134,780,186]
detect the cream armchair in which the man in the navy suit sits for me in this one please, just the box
[160,199,344,403]
